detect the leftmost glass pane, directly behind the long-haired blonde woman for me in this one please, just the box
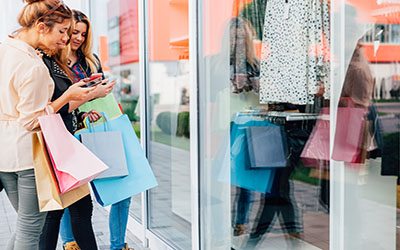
[90,0,142,222]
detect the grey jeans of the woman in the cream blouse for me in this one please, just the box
[0,169,46,250]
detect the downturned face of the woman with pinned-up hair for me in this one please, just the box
[41,20,71,51]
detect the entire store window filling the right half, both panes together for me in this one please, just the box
[198,0,400,249]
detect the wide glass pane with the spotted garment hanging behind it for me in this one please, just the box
[199,0,331,250]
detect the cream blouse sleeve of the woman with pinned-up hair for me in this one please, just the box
[15,66,53,131]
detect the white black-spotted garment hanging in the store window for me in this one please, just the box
[260,0,330,104]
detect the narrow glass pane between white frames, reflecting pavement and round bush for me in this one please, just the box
[147,0,191,249]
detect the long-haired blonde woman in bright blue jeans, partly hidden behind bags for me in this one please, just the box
[56,10,131,250]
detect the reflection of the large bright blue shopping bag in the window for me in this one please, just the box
[218,120,275,193]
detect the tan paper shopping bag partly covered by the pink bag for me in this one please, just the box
[32,132,90,212]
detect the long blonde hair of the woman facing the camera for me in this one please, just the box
[72,10,100,73]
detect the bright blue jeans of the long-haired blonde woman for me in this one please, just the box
[60,198,131,250]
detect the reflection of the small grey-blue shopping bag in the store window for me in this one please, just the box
[246,124,288,168]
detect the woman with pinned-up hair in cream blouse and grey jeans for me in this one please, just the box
[0,0,90,250]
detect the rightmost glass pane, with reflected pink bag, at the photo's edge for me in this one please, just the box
[332,0,400,249]
